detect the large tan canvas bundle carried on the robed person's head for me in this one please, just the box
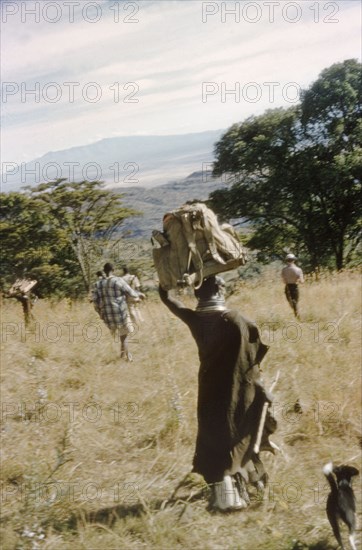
[152,203,246,290]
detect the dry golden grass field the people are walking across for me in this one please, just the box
[1,269,362,550]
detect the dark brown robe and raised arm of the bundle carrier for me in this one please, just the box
[160,288,276,483]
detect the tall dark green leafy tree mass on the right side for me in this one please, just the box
[210,60,362,269]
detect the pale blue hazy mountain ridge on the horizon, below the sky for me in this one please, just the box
[1,130,223,191]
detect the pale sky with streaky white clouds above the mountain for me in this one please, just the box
[1,0,362,163]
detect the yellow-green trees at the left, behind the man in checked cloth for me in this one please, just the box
[0,179,139,296]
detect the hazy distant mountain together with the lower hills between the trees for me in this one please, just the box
[2,130,230,239]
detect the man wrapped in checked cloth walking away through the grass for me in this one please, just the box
[93,263,145,361]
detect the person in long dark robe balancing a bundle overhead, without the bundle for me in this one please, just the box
[159,276,276,511]
